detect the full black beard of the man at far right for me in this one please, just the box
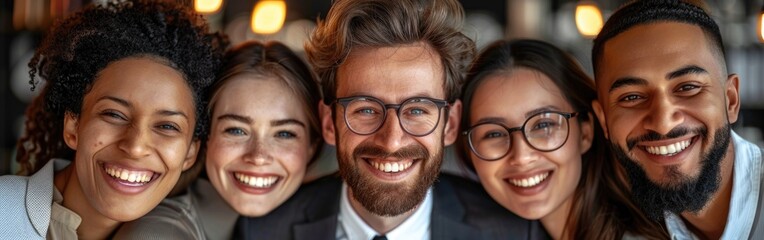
[609,124,730,221]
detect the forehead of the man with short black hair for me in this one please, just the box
[596,22,723,91]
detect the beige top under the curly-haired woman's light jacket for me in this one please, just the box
[47,185,82,239]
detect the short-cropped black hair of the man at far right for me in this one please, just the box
[592,0,726,76]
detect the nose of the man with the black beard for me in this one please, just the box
[644,93,684,135]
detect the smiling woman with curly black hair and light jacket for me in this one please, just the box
[0,1,225,239]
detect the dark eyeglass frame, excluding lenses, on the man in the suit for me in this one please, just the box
[333,95,450,137]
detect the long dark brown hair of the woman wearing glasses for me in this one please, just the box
[457,40,668,239]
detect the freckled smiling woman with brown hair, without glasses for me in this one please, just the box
[115,41,323,239]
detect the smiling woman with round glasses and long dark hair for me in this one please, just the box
[459,40,665,239]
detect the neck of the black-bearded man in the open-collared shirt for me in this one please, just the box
[681,142,735,239]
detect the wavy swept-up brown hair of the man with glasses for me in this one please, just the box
[305,0,476,105]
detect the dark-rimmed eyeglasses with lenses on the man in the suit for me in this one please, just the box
[335,96,448,137]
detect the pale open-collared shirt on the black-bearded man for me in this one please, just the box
[665,131,763,239]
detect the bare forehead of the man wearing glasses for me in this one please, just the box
[337,43,445,102]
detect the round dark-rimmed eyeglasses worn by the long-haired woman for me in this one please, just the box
[462,111,578,161]
